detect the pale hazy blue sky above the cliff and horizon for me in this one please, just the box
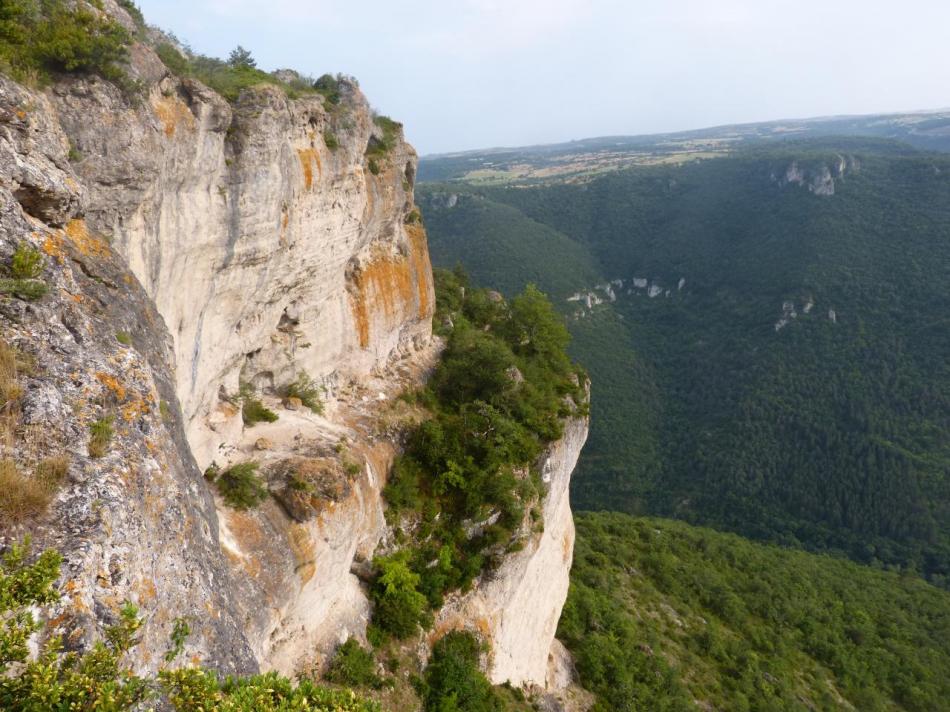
[139,0,950,154]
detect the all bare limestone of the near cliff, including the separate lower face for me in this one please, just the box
[0,1,587,700]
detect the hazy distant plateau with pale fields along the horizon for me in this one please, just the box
[419,109,950,184]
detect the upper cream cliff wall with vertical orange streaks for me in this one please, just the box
[53,69,434,467]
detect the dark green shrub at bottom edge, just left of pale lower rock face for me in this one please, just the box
[422,631,504,712]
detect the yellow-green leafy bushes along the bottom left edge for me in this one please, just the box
[0,544,380,712]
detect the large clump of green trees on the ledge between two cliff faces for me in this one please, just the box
[372,272,586,637]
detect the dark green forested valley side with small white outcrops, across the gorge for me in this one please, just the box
[421,139,950,585]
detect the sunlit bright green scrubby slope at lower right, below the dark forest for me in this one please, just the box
[558,513,950,712]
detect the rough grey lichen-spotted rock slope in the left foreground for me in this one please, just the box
[0,76,257,672]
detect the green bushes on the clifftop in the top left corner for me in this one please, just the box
[0,0,132,83]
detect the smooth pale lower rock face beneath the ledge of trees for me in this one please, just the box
[435,418,588,689]
